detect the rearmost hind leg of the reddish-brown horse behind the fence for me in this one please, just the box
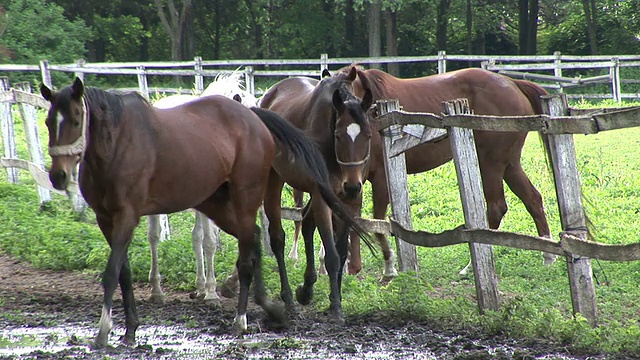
[504,162,557,265]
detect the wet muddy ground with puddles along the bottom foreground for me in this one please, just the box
[0,254,628,359]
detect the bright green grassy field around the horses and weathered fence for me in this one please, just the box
[0,97,640,354]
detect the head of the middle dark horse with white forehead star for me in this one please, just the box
[331,71,372,199]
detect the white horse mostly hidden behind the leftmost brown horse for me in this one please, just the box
[147,72,258,303]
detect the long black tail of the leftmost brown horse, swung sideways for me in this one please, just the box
[251,107,376,253]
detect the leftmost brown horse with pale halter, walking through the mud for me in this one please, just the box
[40,78,360,347]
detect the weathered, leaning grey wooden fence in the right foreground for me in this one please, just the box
[376,94,640,325]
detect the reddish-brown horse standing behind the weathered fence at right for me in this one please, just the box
[339,66,555,273]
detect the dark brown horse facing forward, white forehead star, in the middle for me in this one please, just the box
[260,69,371,323]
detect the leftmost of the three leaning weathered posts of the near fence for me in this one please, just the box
[376,100,418,271]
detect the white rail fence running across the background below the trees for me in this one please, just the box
[0,51,640,101]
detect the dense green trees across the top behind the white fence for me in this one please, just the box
[0,0,640,83]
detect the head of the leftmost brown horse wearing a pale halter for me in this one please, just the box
[40,78,89,190]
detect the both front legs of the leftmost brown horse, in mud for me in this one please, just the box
[94,211,139,348]
